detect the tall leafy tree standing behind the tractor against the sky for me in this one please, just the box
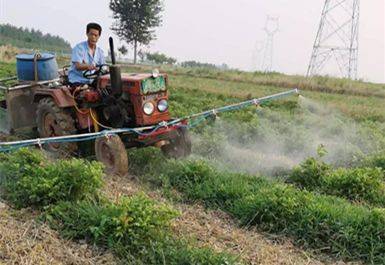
[110,0,163,63]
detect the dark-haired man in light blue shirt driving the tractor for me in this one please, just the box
[68,23,105,87]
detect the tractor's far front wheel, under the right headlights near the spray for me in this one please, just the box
[161,127,191,158]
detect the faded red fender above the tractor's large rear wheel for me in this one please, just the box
[33,88,75,108]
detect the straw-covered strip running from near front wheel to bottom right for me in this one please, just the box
[105,174,354,265]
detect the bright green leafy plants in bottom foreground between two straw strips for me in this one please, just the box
[46,194,236,265]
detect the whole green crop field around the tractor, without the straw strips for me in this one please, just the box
[0,60,385,264]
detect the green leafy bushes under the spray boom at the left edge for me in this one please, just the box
[0,149,103,208]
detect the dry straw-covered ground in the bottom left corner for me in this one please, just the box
[0,201,116,265]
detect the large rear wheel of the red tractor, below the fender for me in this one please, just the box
[36,98,78,158]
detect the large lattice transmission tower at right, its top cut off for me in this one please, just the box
[307,0,360,79]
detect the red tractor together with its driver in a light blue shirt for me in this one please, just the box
[9,23,191,175]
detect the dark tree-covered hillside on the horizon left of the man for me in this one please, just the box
[0,24,71,53]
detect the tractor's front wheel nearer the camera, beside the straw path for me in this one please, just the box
[95,135,128,176]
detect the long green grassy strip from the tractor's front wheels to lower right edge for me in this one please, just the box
[130,147,385,264]
